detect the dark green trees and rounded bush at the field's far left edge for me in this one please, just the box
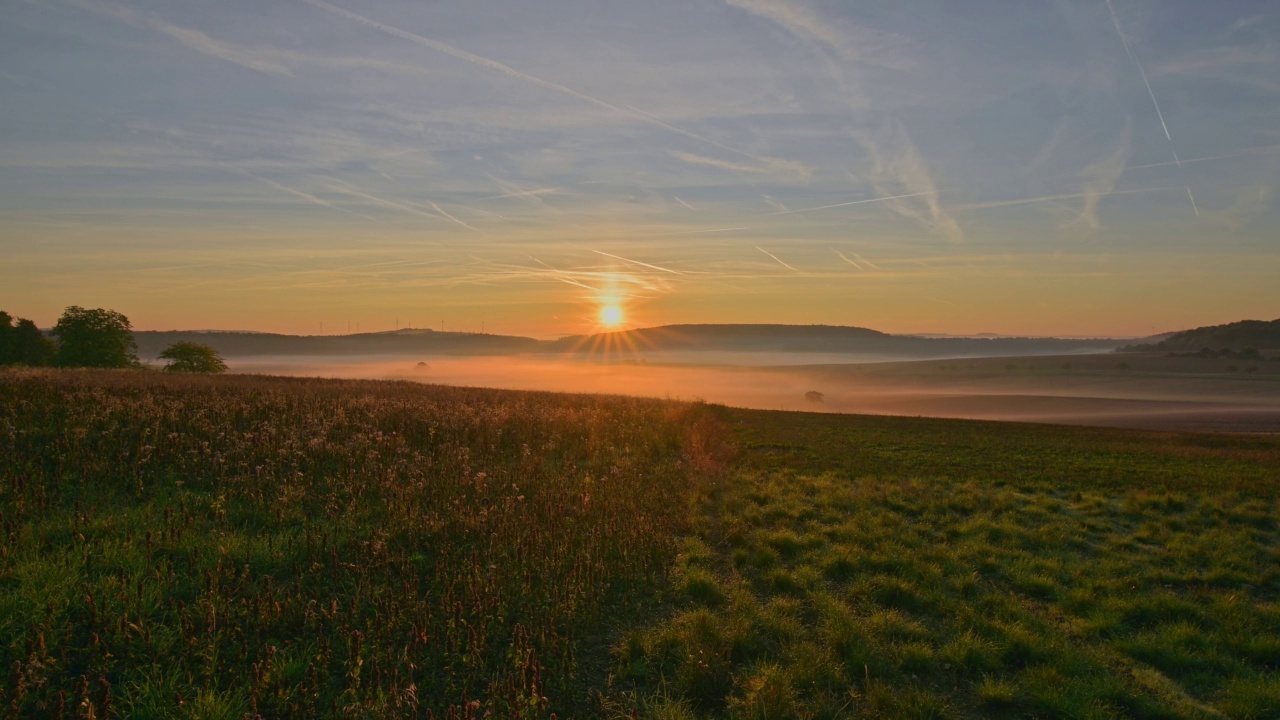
[0,305,227,373]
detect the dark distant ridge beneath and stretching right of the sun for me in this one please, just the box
[540,325,1124,357]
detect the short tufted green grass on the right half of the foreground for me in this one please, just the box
[616,411,1280,717]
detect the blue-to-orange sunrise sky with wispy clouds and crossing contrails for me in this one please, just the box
[0,0,1280,337]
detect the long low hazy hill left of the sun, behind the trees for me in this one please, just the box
[133,329,539,359]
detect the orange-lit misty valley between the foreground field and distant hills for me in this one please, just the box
[228,352,1280,432]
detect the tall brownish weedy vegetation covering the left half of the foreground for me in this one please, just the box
[0,370,716,719]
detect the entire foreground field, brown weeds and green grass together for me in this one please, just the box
[0,370,1280,719]
